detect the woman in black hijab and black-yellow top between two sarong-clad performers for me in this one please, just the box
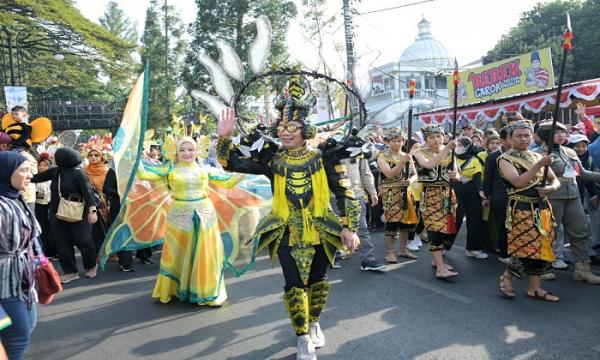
[453,137,488,259]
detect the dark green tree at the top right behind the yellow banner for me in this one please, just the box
[483,0,600,83]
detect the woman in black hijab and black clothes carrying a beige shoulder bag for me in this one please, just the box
[31,148,98,284]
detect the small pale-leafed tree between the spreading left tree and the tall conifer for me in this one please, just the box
[100,1,138,100]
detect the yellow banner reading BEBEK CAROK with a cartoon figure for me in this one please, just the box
[447,47,554,106]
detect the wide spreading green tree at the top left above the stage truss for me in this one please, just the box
[0,0,132,107]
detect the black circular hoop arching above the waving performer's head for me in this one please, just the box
[232,68,367,138]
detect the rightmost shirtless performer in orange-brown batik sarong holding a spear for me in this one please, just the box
[498,121,560,302]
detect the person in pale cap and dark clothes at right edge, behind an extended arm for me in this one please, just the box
[567,134,600,265]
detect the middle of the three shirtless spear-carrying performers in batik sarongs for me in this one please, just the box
[415,125,459,279]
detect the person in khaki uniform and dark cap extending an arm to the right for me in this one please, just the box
[535,121,600,285]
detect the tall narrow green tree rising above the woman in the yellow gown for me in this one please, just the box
[140,0,187,128]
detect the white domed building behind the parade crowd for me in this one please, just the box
[367,18,454,128]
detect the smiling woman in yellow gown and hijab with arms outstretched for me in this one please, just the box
[137,137,233,306]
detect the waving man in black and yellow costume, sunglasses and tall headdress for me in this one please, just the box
[217,76,360,360]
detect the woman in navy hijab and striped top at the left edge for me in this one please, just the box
[0,151,40,360]
